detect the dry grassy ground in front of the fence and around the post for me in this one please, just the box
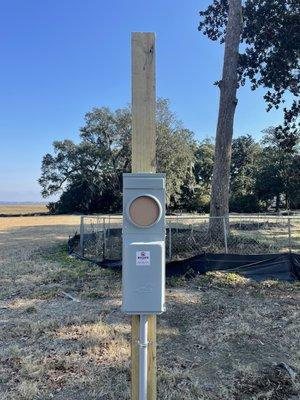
[0,217,300,400]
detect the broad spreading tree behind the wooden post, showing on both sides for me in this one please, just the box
[39,99,194,213]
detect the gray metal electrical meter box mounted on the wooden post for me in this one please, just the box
[122,173,165,314]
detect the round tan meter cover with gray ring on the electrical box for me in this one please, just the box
[129,196,161,228]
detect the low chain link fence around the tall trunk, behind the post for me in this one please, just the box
[69,215,300,261]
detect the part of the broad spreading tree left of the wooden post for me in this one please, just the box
[39,108,131,212]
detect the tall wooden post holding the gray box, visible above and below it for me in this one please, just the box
[131,32,156,400]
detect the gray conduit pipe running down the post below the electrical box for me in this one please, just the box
[139,314,148,400]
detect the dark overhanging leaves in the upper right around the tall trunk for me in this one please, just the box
[199,0,300,128]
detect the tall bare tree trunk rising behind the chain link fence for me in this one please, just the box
[210,0,242,233]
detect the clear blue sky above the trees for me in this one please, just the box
[0,0,281,201]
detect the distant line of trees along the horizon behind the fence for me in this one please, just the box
[39,99,300,213]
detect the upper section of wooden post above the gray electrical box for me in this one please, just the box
[131,32,156,172]
